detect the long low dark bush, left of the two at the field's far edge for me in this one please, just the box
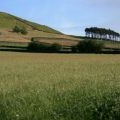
[28,39,61,52]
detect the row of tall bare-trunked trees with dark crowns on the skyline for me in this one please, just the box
[85,27,120,41]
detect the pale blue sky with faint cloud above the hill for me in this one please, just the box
[0,0,120,35]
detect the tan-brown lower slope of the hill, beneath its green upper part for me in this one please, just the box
[0,29,78,42]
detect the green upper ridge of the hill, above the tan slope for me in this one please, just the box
[0,12,61,34]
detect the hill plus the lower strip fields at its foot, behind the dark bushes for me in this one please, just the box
[0,12,120,53]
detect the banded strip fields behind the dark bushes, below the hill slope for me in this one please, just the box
[0,36,120,54]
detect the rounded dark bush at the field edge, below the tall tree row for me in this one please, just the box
[76,40,104,53]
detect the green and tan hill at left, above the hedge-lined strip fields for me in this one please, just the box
[0,12,80,42]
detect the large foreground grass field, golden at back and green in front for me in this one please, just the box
[0,52,120,120]
